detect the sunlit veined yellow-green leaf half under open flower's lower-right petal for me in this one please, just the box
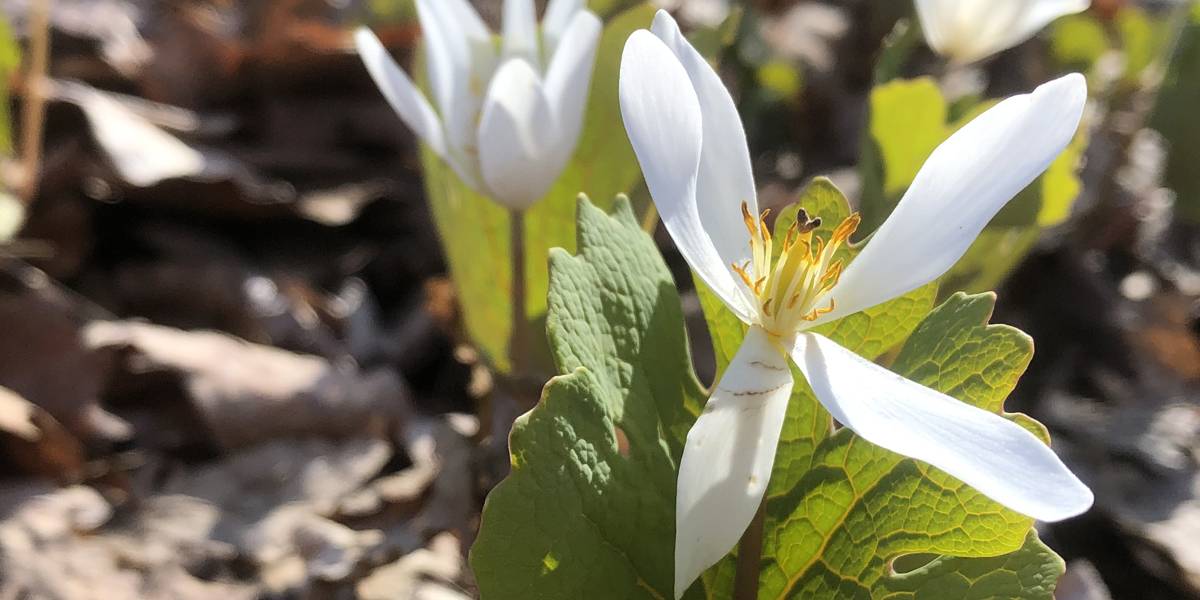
[760,294,1062,600]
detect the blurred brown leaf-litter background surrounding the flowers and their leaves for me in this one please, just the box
[0,0,1200,600]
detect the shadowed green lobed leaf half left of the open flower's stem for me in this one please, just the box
[470,199,704,600]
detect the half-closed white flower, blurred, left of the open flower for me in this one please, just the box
[355,0,601,210]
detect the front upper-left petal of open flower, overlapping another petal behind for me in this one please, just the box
[619,30,752,323]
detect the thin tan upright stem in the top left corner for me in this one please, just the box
[20,0,50,206]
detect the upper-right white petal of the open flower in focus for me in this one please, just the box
[815,74,1087,324]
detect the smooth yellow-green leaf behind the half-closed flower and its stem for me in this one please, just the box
[422,4,654,372]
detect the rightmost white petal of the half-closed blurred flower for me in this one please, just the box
[546,11,602,159]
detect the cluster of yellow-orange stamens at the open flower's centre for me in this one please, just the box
[731,202,862,337]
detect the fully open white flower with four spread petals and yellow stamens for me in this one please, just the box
[620,12,1092,598]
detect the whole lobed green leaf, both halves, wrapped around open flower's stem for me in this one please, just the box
[470,194,1063,600]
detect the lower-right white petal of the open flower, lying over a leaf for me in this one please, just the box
[792,334,1092,521]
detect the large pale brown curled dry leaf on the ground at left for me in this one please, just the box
[84,322,409,449]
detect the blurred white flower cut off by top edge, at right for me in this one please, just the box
[916,0,1091,65]
